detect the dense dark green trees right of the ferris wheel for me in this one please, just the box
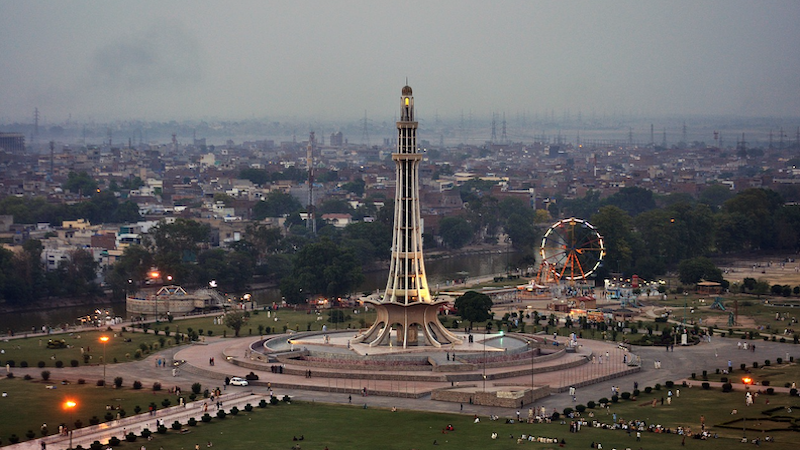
[559,185,800,278]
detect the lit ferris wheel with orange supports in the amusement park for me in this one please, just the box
[539,217,606,281]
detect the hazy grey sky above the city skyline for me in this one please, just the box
[0,0,800,123]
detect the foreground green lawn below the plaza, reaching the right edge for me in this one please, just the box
[34,390,800,450]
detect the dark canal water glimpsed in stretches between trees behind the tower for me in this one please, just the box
[0,251,519,334]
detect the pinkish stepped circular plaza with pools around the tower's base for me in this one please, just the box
[181,330,640,407]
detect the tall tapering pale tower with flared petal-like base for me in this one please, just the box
[356,86,461,348]
